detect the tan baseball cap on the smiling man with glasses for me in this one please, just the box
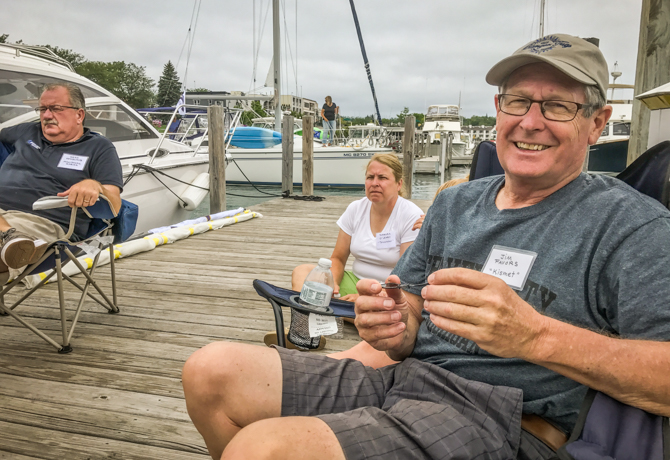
[486,34,609,100]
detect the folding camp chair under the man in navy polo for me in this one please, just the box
[0,195,137,353]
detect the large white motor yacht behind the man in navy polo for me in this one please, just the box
[0,44,209,233]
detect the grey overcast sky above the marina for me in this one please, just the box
[0,0,642,117]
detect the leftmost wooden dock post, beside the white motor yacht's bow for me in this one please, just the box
[207,105,226,214]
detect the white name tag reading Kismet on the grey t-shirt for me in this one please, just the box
[482,246,537,291]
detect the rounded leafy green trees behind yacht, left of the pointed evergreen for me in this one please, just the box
[77,61,155,109]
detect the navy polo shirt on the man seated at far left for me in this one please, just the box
[0,122,123,239]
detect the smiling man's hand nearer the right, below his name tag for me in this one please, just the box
[421,268,547,359]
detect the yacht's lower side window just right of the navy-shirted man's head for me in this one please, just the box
[84,104,157,142]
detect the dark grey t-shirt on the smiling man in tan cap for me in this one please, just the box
[393,174,670,431]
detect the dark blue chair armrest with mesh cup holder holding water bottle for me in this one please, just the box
[254,280,356,350]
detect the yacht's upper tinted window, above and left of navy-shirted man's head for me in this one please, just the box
[0,70,107,123]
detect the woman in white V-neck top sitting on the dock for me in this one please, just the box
[291,153,423,367]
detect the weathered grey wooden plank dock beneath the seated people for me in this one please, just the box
[0,197,430,460]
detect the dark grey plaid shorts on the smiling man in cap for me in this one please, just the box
[277,348,553,460]
